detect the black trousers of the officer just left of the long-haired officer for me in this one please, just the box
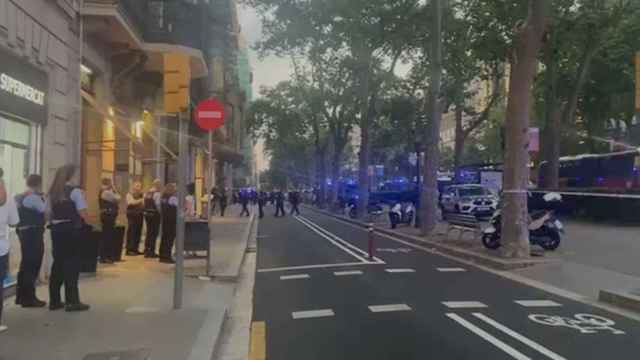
[16,227,44,304]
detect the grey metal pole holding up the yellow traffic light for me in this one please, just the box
[173,110,190,310]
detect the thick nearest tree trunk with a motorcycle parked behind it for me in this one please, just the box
[501,0,549,258]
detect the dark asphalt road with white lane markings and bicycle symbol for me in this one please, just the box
[253,212,640,360]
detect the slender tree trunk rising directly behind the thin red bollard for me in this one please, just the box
[357,45,372,218]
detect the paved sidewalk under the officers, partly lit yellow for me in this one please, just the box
[0,208,253,360]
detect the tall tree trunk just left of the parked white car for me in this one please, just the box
[420,0,442,235]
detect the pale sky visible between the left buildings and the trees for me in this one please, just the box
[238,5,292,172]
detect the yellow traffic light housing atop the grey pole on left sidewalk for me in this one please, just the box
[163,53,191,113]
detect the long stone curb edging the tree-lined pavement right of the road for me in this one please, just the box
[307,206,557,270]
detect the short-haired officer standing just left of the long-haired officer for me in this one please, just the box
[15,174,47,308]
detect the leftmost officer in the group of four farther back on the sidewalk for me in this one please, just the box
[98,178,120,264]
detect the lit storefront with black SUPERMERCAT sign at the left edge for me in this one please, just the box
[0,49,48,285]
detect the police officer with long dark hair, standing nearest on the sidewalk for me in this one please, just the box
[47,165,89,311]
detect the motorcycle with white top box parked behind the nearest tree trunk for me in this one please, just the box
[482,193,564,250]
